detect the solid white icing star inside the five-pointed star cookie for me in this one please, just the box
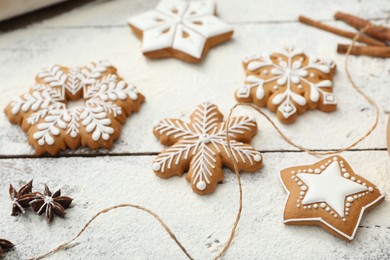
[297,161,367,217]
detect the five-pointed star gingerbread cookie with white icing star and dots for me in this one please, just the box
[280,156,385,241]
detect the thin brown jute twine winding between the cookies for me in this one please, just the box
[30,26,379,260]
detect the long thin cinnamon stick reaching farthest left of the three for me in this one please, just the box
[298,15,386,46]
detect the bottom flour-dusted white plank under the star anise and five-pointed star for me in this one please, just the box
[0,151,390,259]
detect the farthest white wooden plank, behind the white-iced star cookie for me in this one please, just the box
[29,0,389,27]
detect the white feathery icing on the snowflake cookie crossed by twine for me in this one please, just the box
[153,102,261,189]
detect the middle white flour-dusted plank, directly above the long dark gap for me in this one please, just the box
[0,20,390,156]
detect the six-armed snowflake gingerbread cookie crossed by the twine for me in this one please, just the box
[153,102,262,195]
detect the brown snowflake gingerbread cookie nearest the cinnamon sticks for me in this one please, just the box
[235,49,337,124]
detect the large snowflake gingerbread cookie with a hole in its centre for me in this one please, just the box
[5,61,145,155]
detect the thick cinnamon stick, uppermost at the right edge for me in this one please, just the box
[334,12,390,41]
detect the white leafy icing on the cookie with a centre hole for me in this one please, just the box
[11,61,138,146]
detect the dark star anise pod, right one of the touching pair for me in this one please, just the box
[30,184,73,223]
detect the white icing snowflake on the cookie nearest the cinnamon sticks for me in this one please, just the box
[241,49,337,118]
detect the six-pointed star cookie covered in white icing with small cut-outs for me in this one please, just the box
[128,0,233,62]
